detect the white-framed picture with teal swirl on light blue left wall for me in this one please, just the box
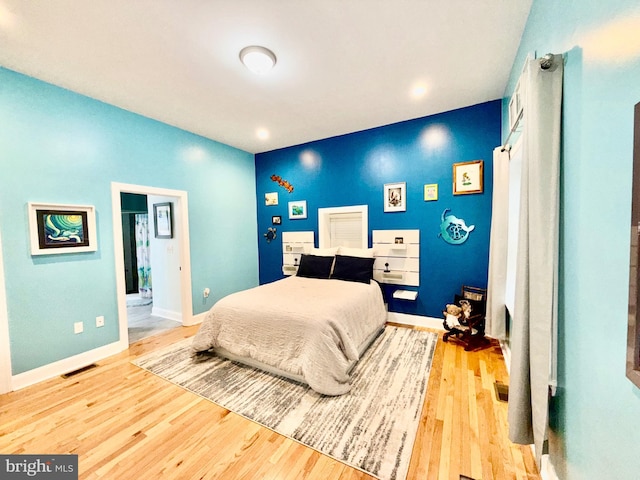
[27,202,98,255]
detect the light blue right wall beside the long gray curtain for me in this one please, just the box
[503,0,640,480]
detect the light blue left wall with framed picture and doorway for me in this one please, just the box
[0,68,258,374]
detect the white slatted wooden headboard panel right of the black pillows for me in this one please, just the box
[372,230,420,287]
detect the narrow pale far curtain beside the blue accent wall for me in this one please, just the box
[486,147,509,340]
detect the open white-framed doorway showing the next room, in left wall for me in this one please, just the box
[111,182,193,348]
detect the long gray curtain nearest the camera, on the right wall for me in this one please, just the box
[508,55,563,464]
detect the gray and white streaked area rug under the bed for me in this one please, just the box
[133,326,438,480]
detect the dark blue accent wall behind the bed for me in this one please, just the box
[256,100,501,318]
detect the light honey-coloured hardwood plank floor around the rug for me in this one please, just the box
[0,326,540,480]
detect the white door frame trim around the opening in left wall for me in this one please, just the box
[111,182,195,350]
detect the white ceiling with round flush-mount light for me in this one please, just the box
[0,0,532,153]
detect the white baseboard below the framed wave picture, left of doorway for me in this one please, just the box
[11,342,128,390]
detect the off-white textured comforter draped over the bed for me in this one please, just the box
[192,276,386,395]
